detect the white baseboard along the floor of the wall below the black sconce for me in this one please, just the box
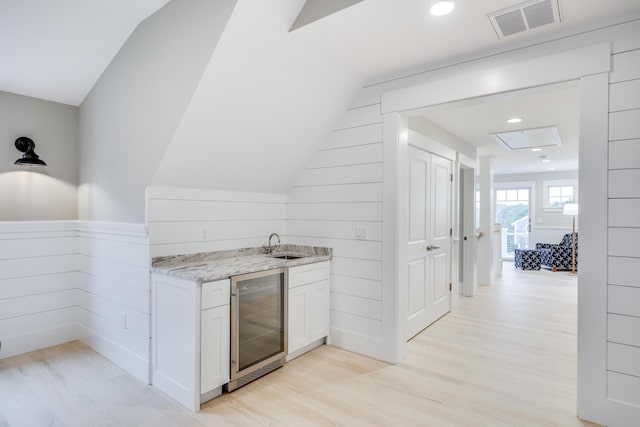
[0,323,81,359]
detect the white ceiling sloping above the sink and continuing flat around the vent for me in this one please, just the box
[153,0,640,193]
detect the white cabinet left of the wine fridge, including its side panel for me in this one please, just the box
[151,273,230,411]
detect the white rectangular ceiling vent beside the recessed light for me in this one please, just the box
[487,0,562,38]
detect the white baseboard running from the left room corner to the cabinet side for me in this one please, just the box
[78,325,151,384]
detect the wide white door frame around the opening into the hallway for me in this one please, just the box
[381,42,611,423]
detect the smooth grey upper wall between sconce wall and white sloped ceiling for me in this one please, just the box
[79,0,235,222]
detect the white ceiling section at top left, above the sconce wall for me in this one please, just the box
[0,0,169,105]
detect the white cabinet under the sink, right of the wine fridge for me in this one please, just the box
[287,261,330,360]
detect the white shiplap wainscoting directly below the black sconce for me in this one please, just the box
[0,222,79,358]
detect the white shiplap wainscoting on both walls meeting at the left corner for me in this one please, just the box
[0,221,151,382]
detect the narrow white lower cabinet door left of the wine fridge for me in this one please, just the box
[200,305,231,394]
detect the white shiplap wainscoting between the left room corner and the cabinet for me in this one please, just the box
[77,222,151,382]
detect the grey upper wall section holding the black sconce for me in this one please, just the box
[0,92,78,221]
